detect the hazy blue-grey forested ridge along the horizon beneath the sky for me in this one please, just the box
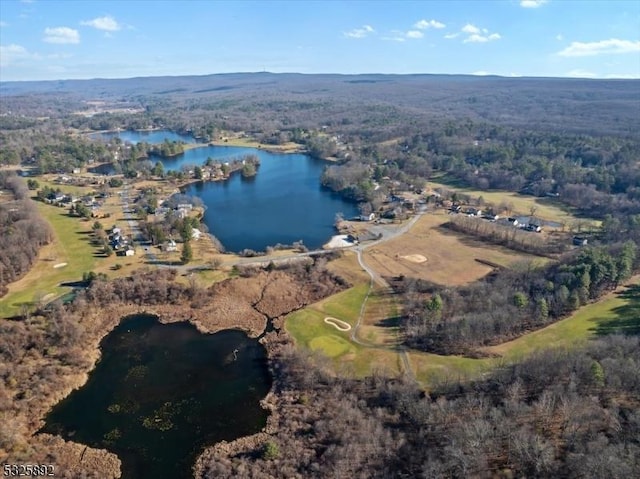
[0,72,640,135]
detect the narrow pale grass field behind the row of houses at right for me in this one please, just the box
[427,176,599,228]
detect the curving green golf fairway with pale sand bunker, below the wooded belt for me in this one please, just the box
[285,274,640,385]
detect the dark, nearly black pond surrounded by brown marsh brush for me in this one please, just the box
[41,315,271,479]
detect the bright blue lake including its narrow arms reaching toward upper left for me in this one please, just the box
[91,130,358,251]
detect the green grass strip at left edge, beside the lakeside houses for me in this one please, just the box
[0,203,96,317]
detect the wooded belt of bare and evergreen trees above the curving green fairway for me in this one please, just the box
[402,241,640,355]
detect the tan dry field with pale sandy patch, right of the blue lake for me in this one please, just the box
[364,211,543,285]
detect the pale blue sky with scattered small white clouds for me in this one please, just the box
[0,0,640,81]
